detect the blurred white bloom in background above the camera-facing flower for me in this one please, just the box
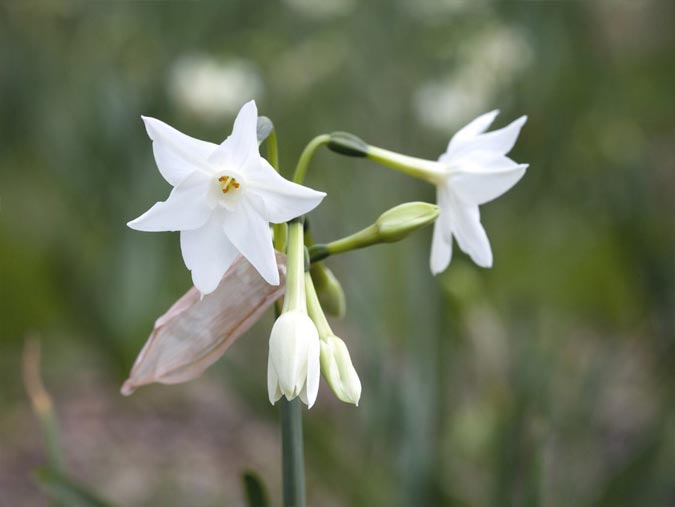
[169,55,264,120]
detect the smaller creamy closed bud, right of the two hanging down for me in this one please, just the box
[321,335,361,406]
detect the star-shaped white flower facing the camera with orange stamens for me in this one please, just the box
[127,101,326,294]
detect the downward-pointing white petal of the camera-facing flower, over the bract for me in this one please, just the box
[180,213,238,295]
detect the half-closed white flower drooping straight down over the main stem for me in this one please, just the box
[267,310,321,408]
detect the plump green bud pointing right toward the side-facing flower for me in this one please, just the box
[375,202,440,243]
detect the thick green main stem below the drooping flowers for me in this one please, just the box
[279,398,305,507]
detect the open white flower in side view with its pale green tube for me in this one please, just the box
[367,111,528,274]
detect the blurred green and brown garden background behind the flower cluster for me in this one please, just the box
[0,0,675,507]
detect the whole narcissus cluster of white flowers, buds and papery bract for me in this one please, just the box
[122,101,528,407]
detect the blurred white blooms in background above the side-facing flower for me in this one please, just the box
[413,25,533,131]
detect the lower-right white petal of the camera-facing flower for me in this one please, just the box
[223,196,279,285]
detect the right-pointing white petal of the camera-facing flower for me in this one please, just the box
[246,158,326,224]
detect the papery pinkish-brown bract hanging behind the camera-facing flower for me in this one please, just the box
[121,253,286,396]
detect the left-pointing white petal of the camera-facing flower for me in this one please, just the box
[127,172,211,232]
